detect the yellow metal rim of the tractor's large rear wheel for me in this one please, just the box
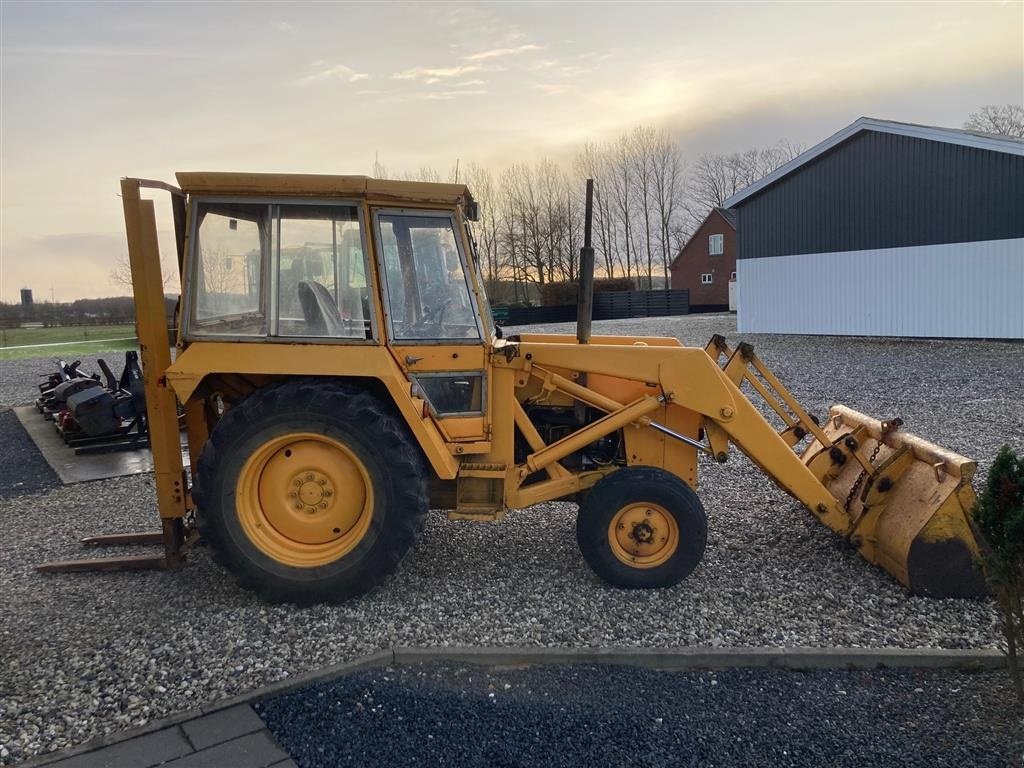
[236,432,374,567]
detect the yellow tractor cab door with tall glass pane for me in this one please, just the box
[373,208,488,454]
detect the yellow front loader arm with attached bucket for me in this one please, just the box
[509,336,985,597]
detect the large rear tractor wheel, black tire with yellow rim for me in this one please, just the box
[193,379,428,604]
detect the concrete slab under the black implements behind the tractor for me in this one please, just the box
[14,406,188,485]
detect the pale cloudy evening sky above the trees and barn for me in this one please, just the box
[0,0,1024,301]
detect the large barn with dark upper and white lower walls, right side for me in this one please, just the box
[724,118,1024,339]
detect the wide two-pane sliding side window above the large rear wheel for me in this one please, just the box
[187,201,375,341]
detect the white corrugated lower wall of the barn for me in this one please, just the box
[736,239,1024,339]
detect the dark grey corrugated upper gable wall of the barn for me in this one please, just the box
[736,131,1024,259]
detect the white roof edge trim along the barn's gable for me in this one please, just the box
[722,118,1024,208]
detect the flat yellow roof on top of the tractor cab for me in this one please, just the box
[175,171,473,205]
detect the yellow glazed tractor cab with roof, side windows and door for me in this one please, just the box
[178,173,494,441]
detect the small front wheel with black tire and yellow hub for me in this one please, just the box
[577,467,708,589]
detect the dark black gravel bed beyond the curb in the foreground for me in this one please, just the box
[256,664,1024,768]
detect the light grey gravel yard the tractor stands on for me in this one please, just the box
[0,315,1024,763]
